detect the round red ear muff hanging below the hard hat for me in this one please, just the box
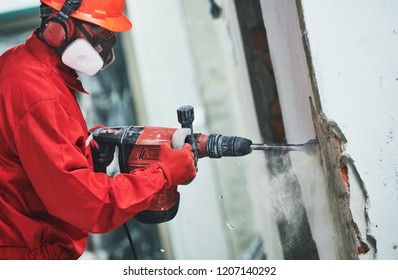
[40,14,75,49]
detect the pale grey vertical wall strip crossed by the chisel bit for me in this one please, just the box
[261,0,338,259]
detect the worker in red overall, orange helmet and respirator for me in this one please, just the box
[0,0,196,259]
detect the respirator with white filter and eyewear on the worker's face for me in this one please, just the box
[61,22,116,76]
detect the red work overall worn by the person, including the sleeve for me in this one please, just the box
[0,33,167,259]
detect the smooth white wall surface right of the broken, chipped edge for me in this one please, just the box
[302,0,398,259]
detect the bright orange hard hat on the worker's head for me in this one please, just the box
[41,0,132,32]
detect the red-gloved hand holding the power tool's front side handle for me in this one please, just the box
[159,142,196,186]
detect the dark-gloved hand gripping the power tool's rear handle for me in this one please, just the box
[89,124,115,172]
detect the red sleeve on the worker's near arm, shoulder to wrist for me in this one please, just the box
[14,100,166,233]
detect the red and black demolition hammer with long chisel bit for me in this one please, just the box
[91,106,318,224]
